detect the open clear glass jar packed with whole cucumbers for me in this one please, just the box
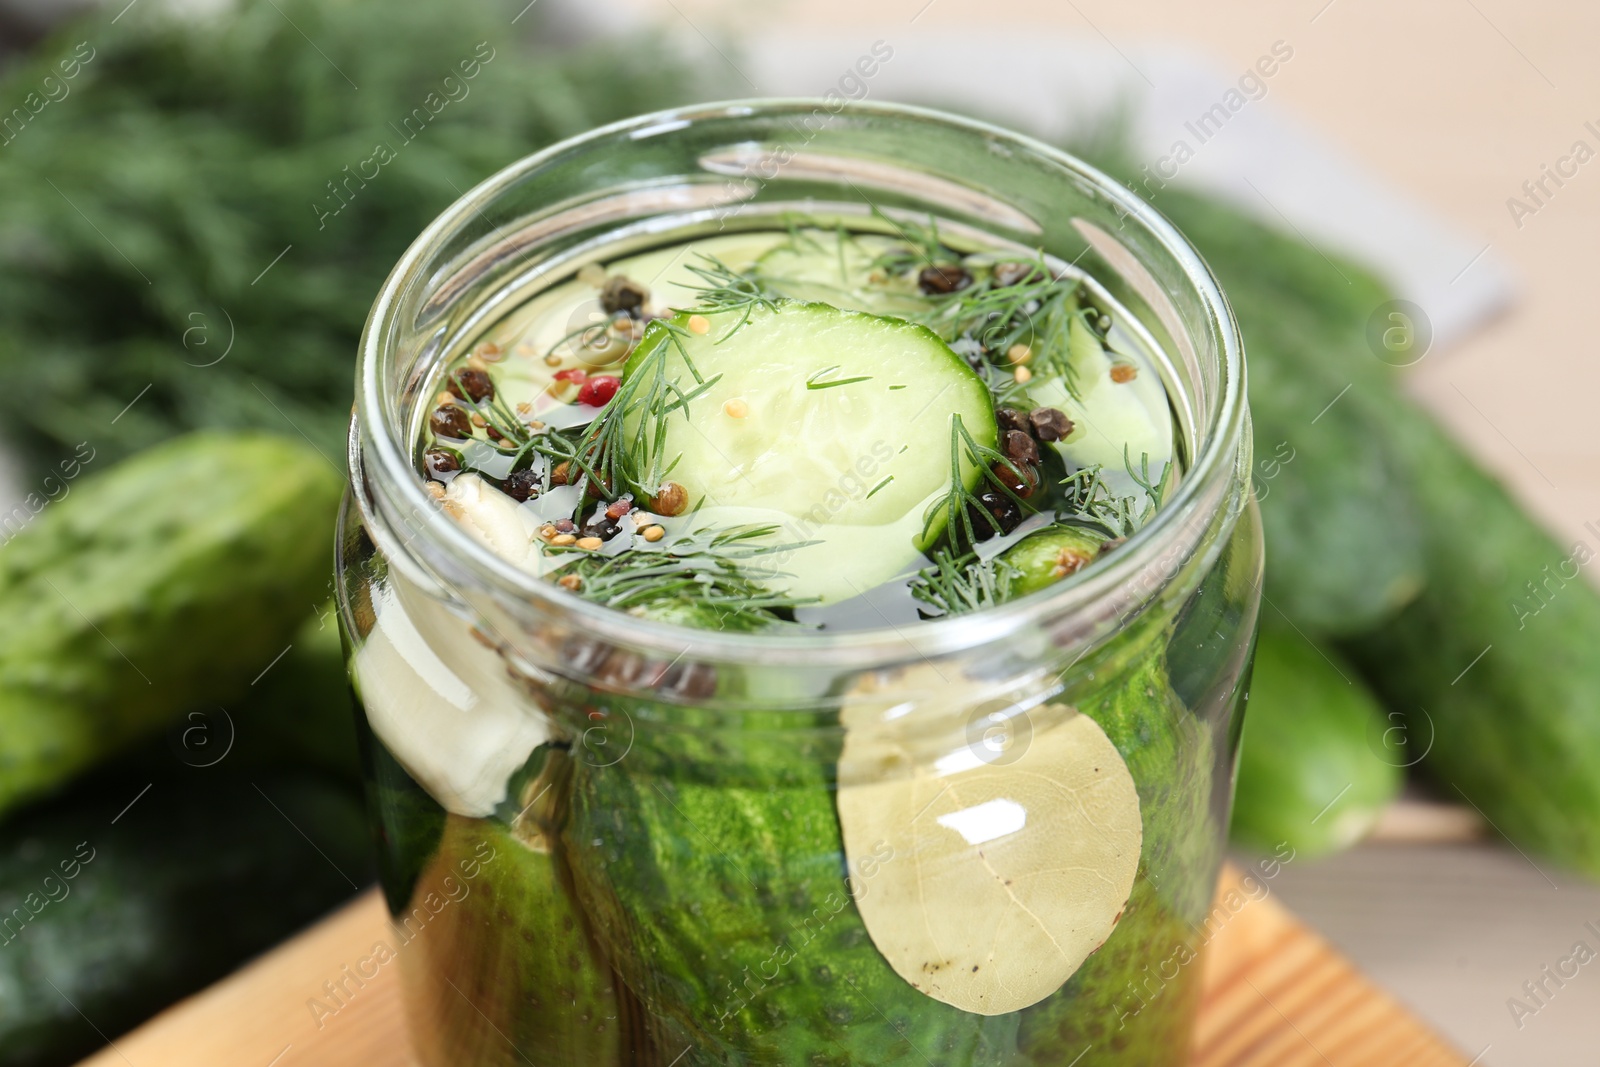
[339,101,1262,1067]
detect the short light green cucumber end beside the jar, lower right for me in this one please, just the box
[1232,625,1403,857]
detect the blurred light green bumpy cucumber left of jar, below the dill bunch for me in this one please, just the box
[0,432,342,813]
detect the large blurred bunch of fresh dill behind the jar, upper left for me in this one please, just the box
[0,0,707,469]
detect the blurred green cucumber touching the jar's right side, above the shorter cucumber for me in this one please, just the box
[1155,190,1426,633]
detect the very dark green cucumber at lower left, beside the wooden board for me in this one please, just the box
[0,768,371,1067]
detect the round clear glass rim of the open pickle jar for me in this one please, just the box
[360,98,1248,665]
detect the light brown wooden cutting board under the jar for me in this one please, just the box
[80,870,1467,1067]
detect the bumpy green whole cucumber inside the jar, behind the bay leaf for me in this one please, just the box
[563,604,1218,1067]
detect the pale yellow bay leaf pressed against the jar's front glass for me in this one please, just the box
[838,705,1144,1016]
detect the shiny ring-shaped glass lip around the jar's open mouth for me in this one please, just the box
[360,98,1248,667]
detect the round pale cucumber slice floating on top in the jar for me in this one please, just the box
[622,301,997,603]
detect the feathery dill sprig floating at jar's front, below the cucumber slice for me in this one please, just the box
[547,525,814,627]
